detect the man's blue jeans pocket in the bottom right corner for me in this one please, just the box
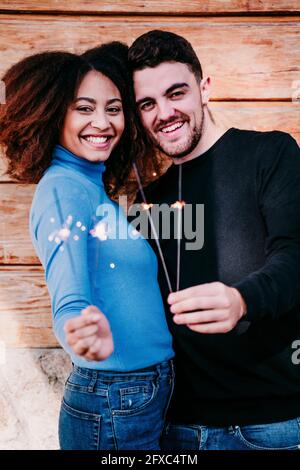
[237,418,300,450]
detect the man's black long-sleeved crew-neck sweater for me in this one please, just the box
[135,128,300,426]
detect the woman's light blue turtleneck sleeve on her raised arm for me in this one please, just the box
[30,176,92,353]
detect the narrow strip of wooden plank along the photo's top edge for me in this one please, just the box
[0,0,300,15]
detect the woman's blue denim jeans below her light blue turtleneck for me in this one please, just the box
[59,361,174,450]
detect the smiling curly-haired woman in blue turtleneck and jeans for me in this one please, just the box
[0,43,174,450]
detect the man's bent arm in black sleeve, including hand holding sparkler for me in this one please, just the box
[168,133,300,333]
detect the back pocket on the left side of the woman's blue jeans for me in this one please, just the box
[59,399,101,450]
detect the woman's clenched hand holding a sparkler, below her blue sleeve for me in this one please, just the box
[64,305,114,361]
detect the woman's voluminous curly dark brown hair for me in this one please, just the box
[0,42,157,196]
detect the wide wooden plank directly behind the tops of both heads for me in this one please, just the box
[0,15,300,100]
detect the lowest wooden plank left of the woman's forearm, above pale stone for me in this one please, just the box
[0,266,58,348]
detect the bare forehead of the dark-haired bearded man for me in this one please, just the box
[133,62,193,98]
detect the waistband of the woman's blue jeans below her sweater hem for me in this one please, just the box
[73,359,174,379]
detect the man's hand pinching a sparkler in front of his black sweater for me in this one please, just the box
[168,282,247,334]
